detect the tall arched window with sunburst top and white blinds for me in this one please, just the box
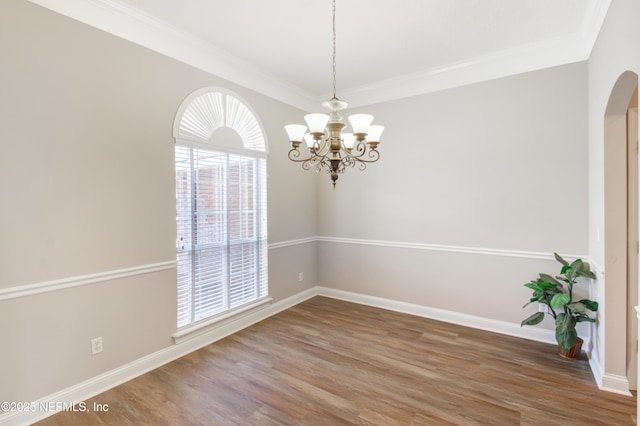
[173,88,268,328]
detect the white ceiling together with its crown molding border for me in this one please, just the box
[30,0,611,110]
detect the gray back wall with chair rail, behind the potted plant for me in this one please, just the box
[318,63,588,326]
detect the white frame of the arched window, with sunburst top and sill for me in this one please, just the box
[174,87,271,336]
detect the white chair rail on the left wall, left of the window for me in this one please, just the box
[0,260,176,301]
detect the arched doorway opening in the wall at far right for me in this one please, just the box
[603,71,638,388]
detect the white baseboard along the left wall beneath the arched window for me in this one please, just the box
[0,289,316,425]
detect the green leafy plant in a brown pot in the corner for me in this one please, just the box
[520,253,598,359]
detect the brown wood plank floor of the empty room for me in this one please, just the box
[39,297,636,426]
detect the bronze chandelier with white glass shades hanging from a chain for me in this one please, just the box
[285,0,384,188]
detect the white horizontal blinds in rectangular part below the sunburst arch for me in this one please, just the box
[175,145,267,327]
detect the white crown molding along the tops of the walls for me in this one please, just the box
[29,0,611,111]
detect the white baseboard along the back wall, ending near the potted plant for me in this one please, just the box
[317,287,557,345]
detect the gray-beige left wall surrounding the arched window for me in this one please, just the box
[0,0,316,401]
